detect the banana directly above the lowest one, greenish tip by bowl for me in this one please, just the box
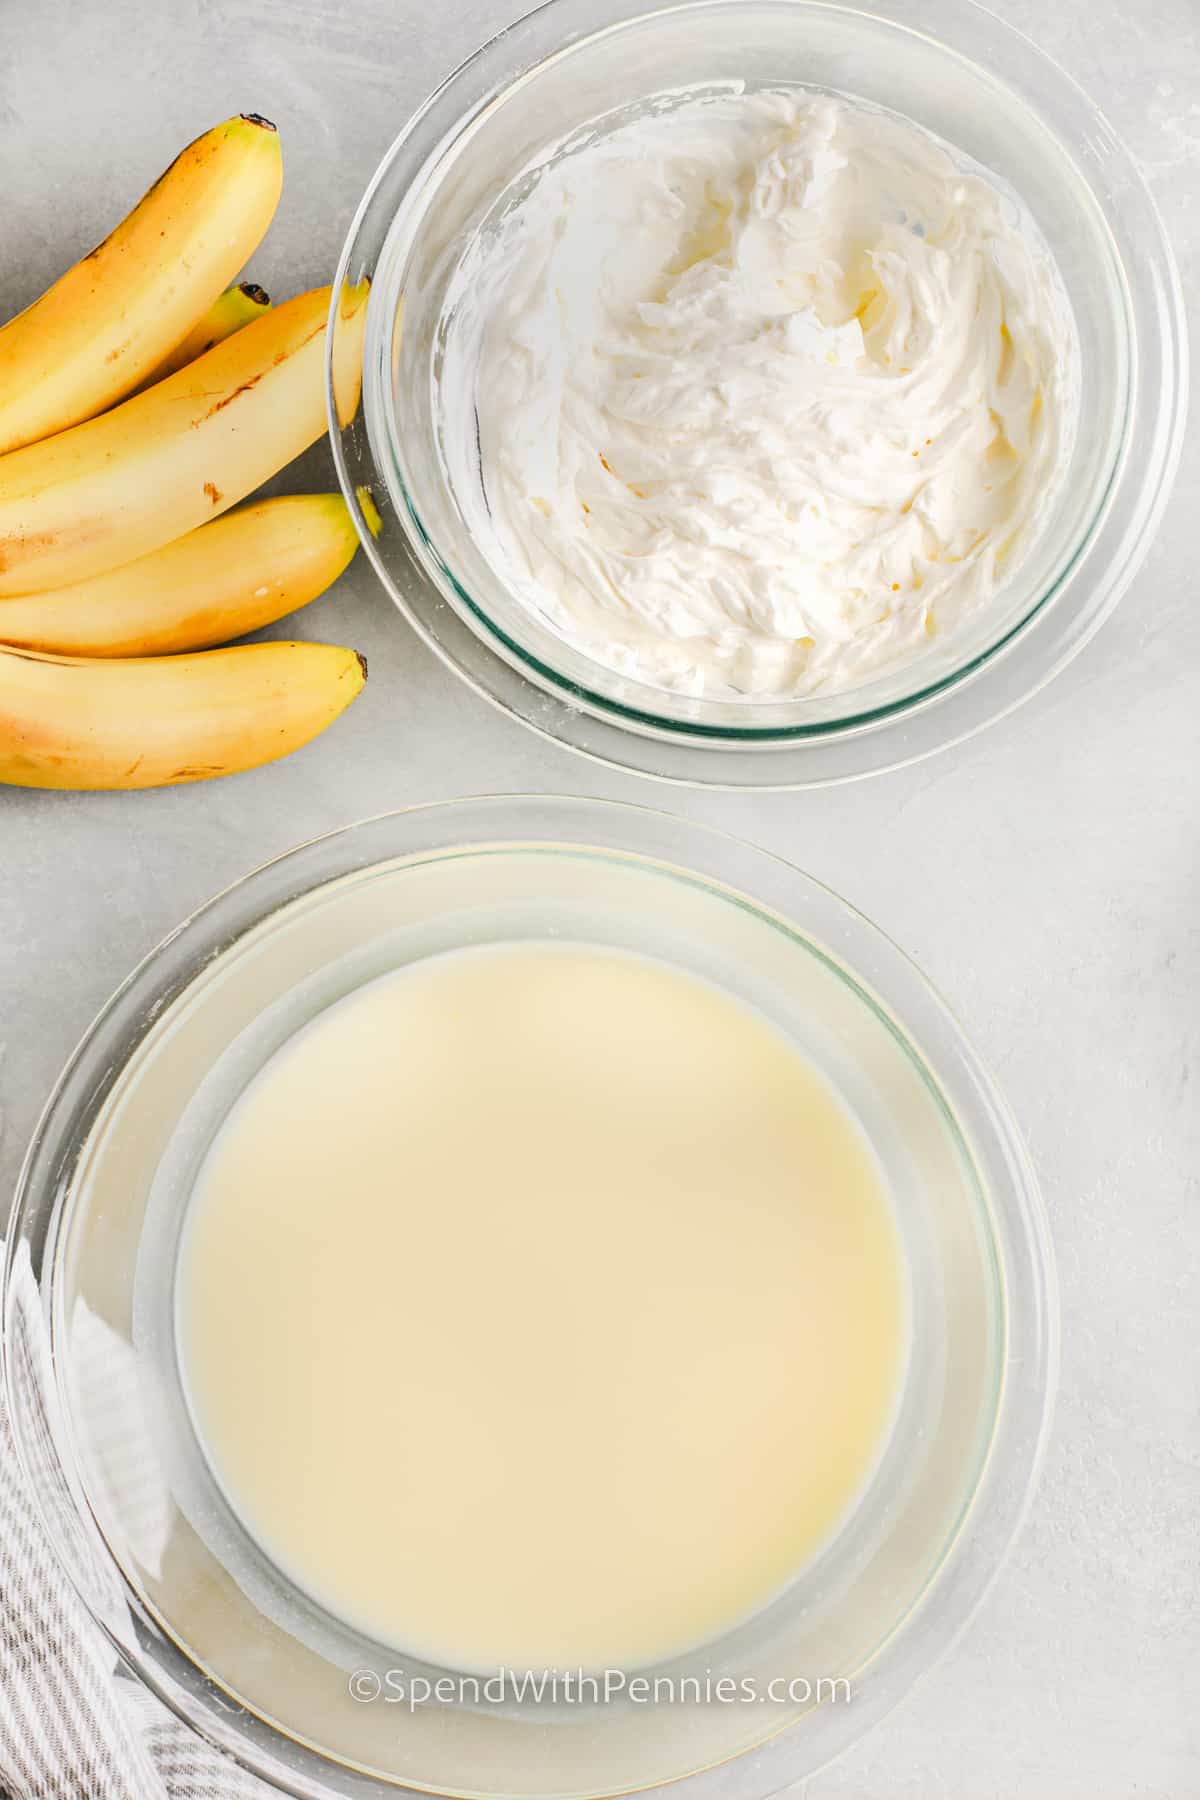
[0,493,358,657]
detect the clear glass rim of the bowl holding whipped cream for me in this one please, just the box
[327,0,1187,788]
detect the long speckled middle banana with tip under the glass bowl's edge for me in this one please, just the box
[0,283,367,594]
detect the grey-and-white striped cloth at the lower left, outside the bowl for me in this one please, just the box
[0,1242,277,1800]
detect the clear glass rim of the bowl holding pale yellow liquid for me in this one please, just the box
[0,794,1060,1800]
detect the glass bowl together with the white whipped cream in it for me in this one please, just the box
[333,0,1186,787]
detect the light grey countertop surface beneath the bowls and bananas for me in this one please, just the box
[0,0,1200,1800]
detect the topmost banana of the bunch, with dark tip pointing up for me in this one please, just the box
[0,113,282,452]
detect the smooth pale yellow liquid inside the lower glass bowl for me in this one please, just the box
[178,945,905,1670]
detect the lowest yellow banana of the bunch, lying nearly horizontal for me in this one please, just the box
[0,643,367,788]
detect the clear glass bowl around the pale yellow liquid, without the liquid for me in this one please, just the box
[4,797,1058,1800]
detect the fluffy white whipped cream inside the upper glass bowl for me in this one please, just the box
[437,86,1078,700]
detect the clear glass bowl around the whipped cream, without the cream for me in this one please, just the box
[323,0,1186,787]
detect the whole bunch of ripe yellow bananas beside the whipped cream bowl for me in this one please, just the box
[0,113,367,788]
